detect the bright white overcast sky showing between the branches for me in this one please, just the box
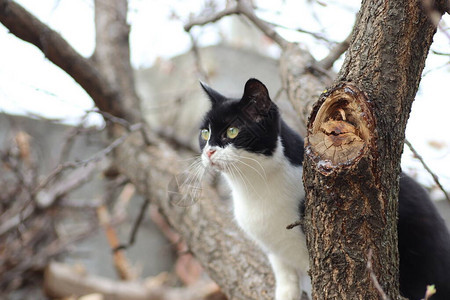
[0,0,450,196]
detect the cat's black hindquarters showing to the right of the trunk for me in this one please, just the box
[398,174,450,300]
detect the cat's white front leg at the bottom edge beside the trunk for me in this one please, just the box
[268,254,300,300]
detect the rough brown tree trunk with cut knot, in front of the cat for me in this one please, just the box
[303,0,443,299]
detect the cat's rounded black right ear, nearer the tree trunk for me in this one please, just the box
[240,78,272,121]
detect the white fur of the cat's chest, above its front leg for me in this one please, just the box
[224,141,308,271]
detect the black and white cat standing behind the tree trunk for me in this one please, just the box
[199,79,450,300]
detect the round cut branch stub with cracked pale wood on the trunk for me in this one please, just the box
[305,83,375,175]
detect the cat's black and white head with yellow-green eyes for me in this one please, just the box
[199,78,280,172]
